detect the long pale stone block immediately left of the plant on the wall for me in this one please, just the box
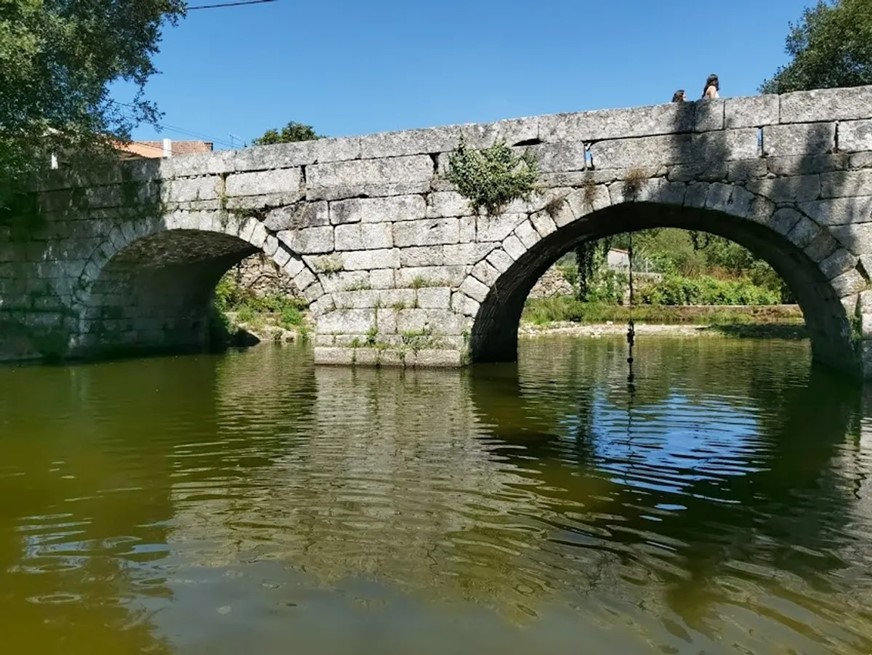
[306,155,433,200]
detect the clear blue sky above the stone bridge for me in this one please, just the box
[119,0,811,149]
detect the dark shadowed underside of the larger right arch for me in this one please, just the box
[470,202,858,373]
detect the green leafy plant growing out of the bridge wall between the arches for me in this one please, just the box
[446,139,539,215]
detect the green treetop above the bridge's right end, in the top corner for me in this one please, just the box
[760,0,872,93]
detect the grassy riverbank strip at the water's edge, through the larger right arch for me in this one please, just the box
[521,296,804,333]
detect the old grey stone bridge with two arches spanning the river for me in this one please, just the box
[0,87,872,377]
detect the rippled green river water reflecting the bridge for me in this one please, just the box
[0,337,872,655]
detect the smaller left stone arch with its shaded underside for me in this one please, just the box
[73,211,324,355]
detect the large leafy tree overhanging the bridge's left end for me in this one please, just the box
[0,0,186,209]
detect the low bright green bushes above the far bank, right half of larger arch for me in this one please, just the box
[637,275,781,305]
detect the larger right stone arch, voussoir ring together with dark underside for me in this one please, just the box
[464,183,867,380]
